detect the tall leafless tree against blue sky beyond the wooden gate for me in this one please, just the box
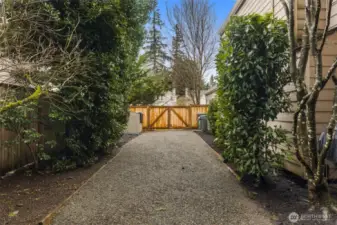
[168,0,217,104]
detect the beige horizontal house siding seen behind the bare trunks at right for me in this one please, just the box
[222,0,337,176]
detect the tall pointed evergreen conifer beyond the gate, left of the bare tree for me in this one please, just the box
[144,0,169,73]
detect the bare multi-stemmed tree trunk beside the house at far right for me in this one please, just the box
[281,0,337,211]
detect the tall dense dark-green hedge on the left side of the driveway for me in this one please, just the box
[46,0,150,170]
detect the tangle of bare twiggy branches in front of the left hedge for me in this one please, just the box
[0,2,87,110]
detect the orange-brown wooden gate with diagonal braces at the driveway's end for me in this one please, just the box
[130,105,208,130]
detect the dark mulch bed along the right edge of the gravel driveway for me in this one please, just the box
[196,131,337,225]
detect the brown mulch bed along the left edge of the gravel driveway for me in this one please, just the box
[0,135,136,225]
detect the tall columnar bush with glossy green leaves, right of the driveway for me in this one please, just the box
[216,14,288,178]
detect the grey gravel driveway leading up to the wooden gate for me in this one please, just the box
[53,131,272,225]
